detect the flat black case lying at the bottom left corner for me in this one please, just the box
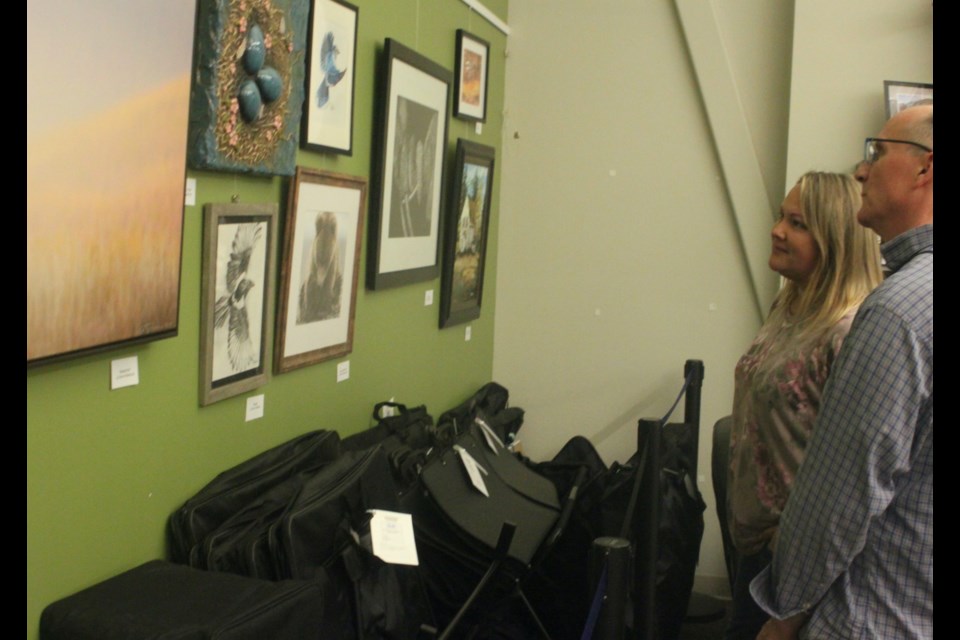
[40,560,343,640]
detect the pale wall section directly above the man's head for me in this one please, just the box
[787,0,942,182]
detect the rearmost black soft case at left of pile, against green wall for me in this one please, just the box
[168,430,340,568]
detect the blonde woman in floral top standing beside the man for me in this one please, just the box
[726,172,882,640]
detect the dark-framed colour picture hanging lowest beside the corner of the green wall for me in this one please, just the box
[440,138,496,329]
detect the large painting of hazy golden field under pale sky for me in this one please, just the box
[27,0,196,368]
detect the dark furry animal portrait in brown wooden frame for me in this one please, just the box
[274,167,367,373]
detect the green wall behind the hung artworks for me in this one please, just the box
[27,0,508,638]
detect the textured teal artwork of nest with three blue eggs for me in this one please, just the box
[187,0,309,175]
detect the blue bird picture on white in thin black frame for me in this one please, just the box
[300,0,360,156]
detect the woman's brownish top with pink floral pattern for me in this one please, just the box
[727,309,856,555]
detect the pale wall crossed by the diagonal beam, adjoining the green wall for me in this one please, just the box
[494,0,792,592]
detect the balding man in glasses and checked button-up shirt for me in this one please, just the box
[751,104,933,640]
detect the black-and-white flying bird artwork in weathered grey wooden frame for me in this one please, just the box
[200,204,278,406]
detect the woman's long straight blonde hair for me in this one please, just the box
[767,171,883,337]
